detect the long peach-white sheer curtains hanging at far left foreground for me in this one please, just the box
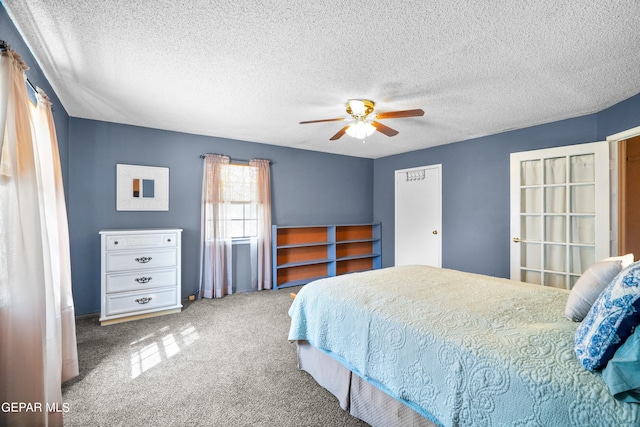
[0,42,78,426]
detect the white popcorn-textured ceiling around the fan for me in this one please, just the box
[0,0,640,158]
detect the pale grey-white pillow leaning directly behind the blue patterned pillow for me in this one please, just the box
[564,254,633,322]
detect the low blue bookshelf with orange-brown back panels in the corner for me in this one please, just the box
[272,223,381,289]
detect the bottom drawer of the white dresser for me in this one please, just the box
[105,287,178,316]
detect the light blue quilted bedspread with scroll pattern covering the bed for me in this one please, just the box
[289,266,640,427]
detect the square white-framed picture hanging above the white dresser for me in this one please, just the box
[116,164,169,211]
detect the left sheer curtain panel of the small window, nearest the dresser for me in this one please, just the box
[200,154,233,298]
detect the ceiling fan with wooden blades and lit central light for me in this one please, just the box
[300,99,424,141]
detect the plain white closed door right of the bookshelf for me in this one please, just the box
[395,165,442,267]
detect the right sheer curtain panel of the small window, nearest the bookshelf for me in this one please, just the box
[249,159,271,290]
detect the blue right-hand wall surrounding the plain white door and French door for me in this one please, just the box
[373,95,640,277]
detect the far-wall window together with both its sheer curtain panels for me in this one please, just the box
[200,153,272,298]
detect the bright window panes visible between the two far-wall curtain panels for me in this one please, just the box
[221,164,258,239]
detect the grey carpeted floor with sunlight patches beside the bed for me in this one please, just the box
[62,288,367,427]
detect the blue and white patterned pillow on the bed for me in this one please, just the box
[575,262,640,371]
